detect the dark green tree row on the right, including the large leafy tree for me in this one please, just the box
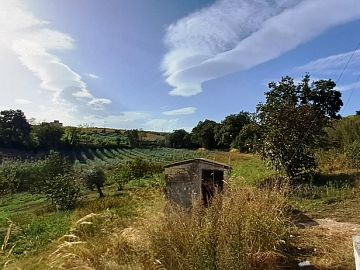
[165,74,360,179]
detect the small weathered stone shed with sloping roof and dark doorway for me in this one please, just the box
[165,158,231,207]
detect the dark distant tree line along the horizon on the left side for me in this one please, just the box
[0,109,147,150]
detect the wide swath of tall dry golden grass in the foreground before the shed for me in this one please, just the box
[9,187,290,270]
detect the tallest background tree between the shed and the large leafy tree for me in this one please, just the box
[215,111,251,148]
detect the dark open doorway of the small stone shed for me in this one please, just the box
[201,170,224,206]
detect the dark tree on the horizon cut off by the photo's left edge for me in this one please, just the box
[0,110,30,147]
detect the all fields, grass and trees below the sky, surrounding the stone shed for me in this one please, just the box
[0,75,360,269]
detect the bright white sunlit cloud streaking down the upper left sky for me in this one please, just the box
[0,0,111,123]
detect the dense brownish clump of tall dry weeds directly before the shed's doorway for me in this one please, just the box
[150,188,290,269]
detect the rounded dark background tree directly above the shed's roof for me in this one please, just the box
[191,119,219,149]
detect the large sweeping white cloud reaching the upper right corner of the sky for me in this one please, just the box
[162,0,360,96]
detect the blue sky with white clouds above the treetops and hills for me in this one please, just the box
[0,0,360,131]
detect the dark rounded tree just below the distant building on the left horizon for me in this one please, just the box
[33,123,64,149]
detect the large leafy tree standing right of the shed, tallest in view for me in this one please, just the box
[257,75,342,179]
